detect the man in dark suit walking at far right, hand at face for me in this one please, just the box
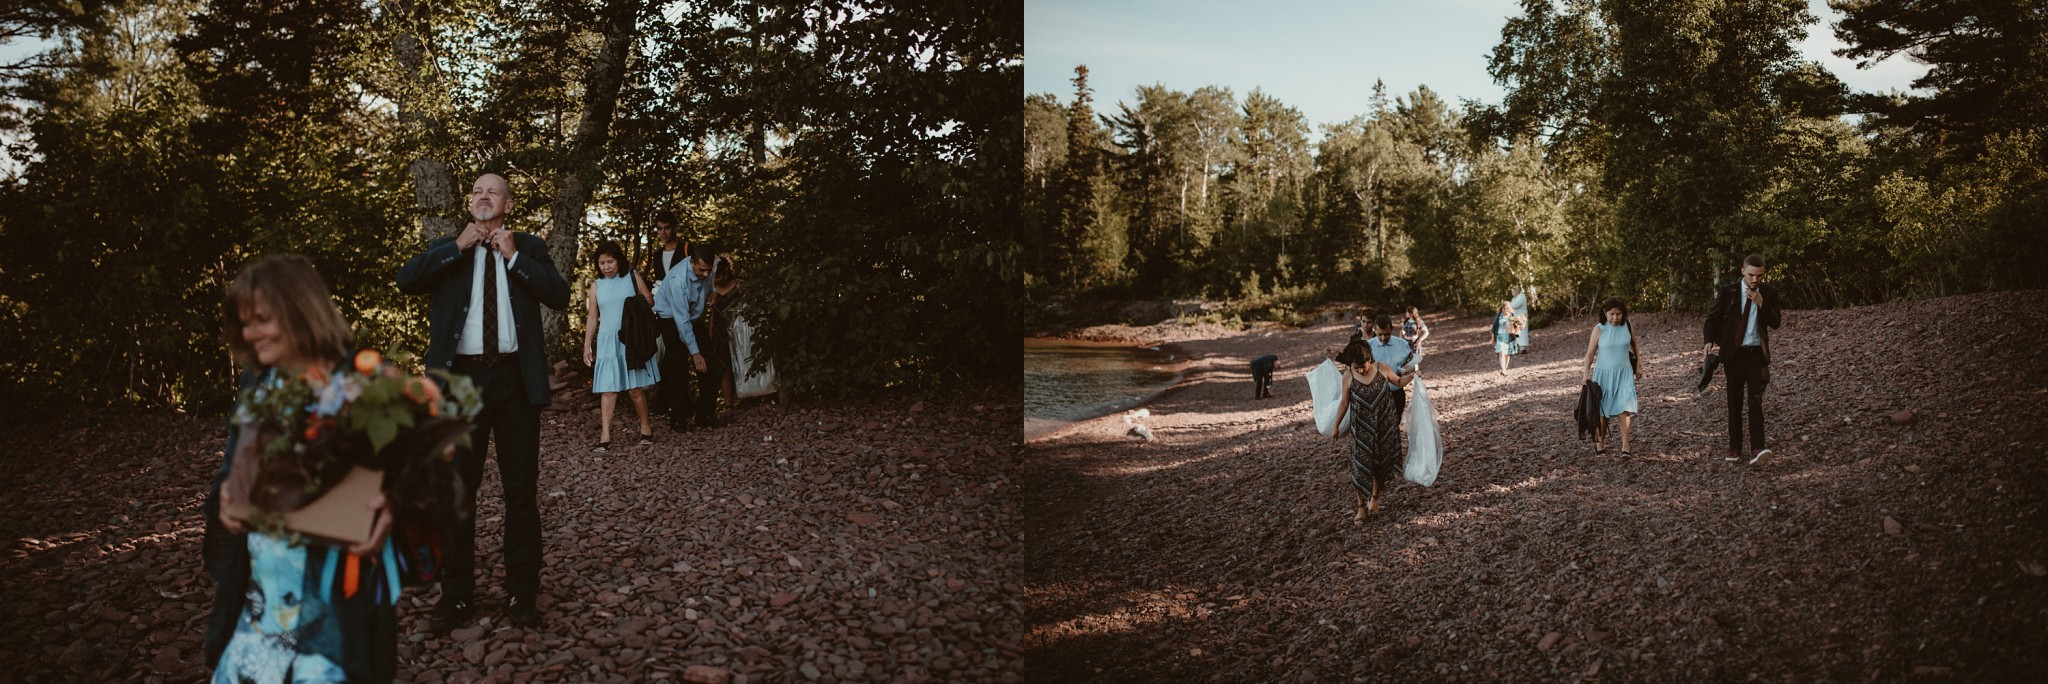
[1704,254,1782,465]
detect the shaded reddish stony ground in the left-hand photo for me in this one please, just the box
[0,387,1024,682]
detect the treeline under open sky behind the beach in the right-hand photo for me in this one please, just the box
[1024,0,2048,323]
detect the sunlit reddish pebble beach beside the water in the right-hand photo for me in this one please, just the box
[1022,291,2048,682]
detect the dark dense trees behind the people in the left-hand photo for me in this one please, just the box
[0,0,1022,417]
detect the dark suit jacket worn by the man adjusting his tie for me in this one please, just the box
[397,233,569,405]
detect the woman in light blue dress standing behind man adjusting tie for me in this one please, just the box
[584,240,662,453]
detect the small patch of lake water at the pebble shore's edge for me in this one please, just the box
[1024,338,1180,438]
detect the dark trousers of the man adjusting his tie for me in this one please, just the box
[440,354,541,600]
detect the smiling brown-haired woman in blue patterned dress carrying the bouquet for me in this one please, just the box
[205,254,419,682]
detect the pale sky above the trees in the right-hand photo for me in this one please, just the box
[1024,0,1927,127]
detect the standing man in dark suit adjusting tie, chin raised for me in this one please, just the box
[397,174,569,631]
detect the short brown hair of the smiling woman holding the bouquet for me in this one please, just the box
[221,254,356,367]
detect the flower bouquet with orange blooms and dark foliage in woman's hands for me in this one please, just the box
[225,350,483,545]
